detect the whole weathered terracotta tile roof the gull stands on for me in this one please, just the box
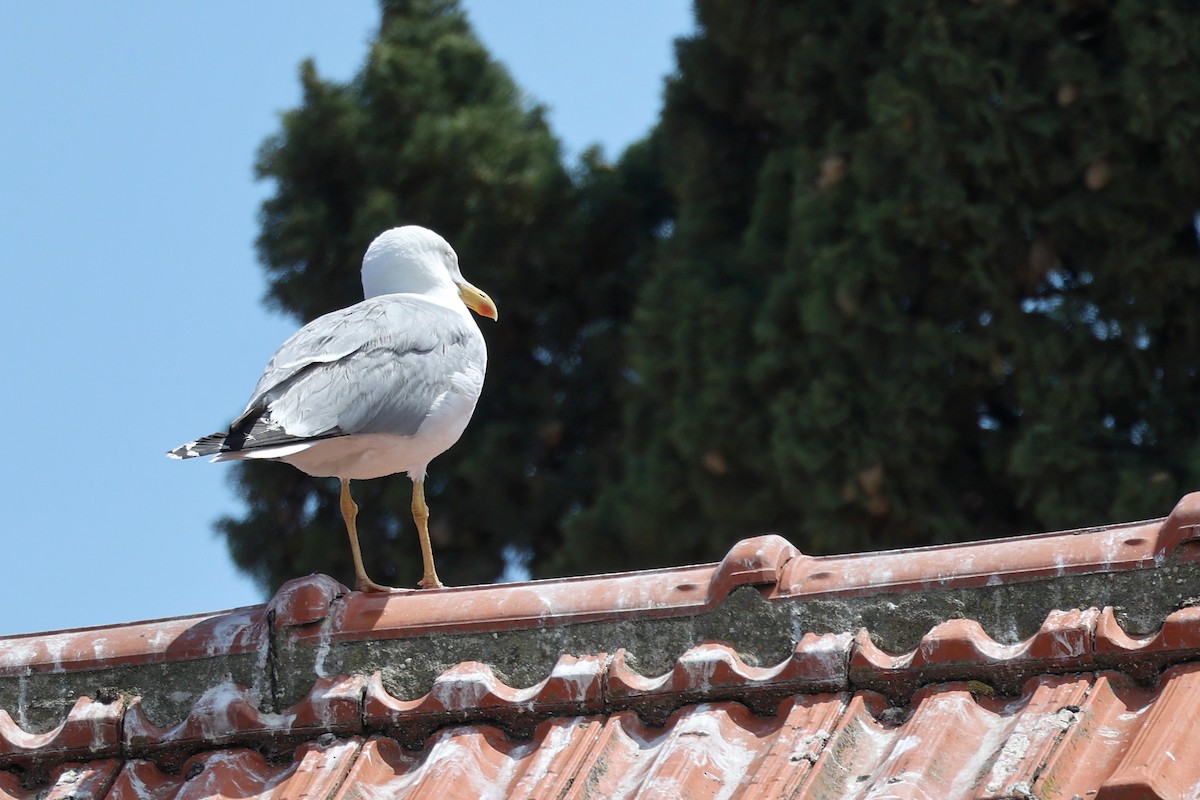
[0,495,1200,800]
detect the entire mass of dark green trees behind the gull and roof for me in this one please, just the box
[222,0,1200,585]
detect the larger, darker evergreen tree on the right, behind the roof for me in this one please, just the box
[562,0,1200,569]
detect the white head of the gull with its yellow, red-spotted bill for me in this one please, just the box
[362,225,498,320]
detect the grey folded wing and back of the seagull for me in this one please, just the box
[234,295,486,446]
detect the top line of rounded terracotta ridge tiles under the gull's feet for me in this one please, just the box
[0,506,1200,678]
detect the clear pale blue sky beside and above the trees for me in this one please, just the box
[0,0,694,634]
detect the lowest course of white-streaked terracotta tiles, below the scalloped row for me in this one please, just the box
[0,666,1200,800]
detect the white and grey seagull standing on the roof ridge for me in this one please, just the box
[167,225,498,591]
